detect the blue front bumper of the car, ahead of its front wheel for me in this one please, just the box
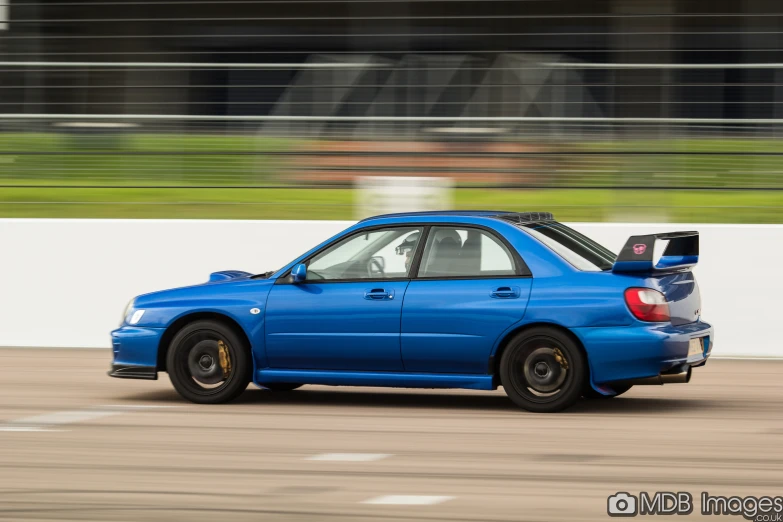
[109,326,164,379]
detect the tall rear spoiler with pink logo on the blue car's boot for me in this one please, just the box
[612,232,699,273]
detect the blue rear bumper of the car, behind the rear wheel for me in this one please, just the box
[573,321,715,387]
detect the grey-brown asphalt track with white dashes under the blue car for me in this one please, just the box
[0,349,783,522]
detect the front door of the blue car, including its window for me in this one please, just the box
[265,226,422,371]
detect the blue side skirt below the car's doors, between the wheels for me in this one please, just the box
[254,368,494,390]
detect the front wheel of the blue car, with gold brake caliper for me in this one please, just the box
[166,320,253,404]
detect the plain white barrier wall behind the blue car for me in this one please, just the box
[0,219,783,357]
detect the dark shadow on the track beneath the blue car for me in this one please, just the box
[122,387,720,415]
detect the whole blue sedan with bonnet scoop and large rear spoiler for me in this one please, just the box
[109,211,713,412]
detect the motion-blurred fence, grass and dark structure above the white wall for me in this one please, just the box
[0,0,783,223]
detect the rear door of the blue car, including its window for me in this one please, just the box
[401,226,532,374]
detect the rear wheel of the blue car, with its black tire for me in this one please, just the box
[500,327,587,413]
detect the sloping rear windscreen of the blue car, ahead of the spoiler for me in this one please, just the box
[517,221,617,272]
